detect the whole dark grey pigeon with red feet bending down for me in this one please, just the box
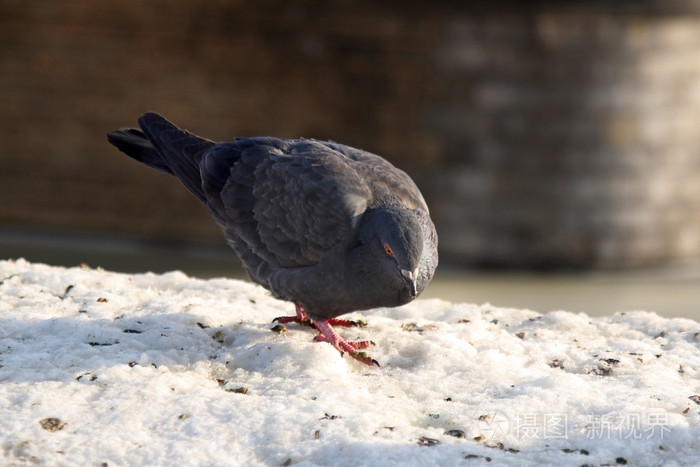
[107,112,438,365]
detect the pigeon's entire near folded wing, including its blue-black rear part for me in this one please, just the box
[202,138,371,270]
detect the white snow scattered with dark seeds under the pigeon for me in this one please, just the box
[0,260,700,466]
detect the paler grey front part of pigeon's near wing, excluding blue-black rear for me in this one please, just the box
[253,140,370,266]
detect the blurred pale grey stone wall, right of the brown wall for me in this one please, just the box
[430,3,700,267]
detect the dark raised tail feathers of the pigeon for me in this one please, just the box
[107,112,215,203]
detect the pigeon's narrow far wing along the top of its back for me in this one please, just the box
[322,142,429,213]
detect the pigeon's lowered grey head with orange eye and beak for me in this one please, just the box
[359,206,423,304]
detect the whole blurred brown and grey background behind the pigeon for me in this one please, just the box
[0,0,700,319]
